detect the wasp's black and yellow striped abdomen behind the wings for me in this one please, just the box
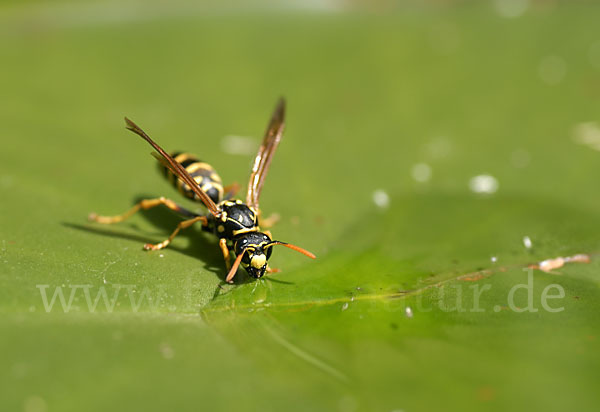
[159,152,223,203]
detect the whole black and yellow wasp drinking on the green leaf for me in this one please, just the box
[89,99,315,283]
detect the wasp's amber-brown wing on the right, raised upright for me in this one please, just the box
[246,98,285,209]
